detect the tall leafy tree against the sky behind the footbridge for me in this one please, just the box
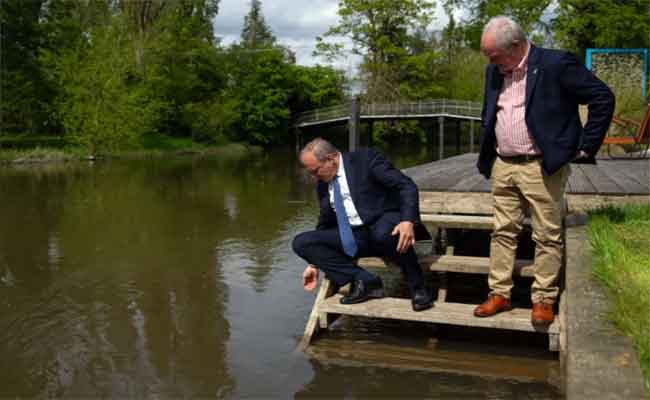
[316,0,433,101]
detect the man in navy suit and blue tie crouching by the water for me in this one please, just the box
[293,138,433,311]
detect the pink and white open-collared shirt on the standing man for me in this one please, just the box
[495,45,541,157]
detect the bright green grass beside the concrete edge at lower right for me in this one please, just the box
[588,204,650,394]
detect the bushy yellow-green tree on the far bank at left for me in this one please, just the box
[53,19,160,155]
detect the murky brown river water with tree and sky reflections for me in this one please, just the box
[0,146,559,399]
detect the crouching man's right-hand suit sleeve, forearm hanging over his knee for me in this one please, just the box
[369,151,420,223]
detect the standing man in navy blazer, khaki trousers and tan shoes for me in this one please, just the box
[474,16,614,325]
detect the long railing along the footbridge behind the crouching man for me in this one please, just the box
[296,99,481,126]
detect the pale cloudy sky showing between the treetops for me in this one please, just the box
[214,0,447,74]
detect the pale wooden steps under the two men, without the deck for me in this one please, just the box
[301,214,564,351]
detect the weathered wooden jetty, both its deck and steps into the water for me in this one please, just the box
[301,153,650,351]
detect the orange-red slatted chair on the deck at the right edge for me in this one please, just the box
[603,104,650,159]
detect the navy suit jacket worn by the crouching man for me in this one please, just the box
[316,149,420,234]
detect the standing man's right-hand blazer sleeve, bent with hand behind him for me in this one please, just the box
[560,53,615,155]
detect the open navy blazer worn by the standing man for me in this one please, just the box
[477,44,615,178]
